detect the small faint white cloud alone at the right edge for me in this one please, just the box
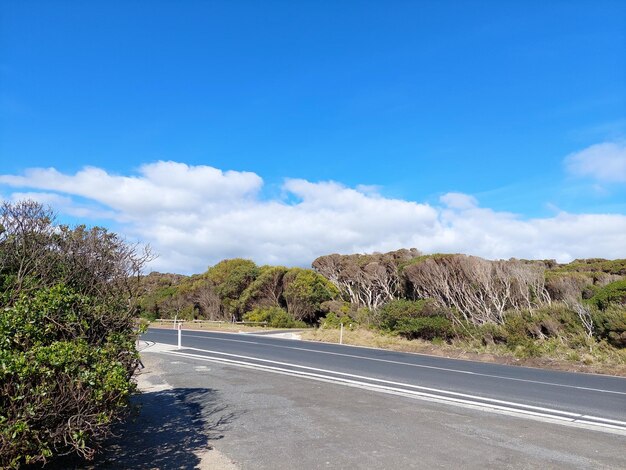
[565,142,626,183]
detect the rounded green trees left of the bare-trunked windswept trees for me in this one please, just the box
[139,258,339,326]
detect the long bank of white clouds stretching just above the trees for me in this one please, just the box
[0,162,626,272]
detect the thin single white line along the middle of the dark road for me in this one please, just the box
[163,335,626,395]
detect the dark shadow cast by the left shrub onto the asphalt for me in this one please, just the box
[45,388,235,470]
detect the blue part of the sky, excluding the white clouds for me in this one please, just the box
[0,0,626,270]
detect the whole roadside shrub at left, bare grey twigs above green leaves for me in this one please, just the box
[0,202,147,468]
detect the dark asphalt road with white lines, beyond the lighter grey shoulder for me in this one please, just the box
[142,329,626,435]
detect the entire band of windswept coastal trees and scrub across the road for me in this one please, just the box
[139,249,626,347]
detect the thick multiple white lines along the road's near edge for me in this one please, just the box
[149,349,626,436]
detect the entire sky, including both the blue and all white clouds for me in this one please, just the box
[0,0,626,273]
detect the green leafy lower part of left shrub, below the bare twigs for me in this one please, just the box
[0,286,136,468]
